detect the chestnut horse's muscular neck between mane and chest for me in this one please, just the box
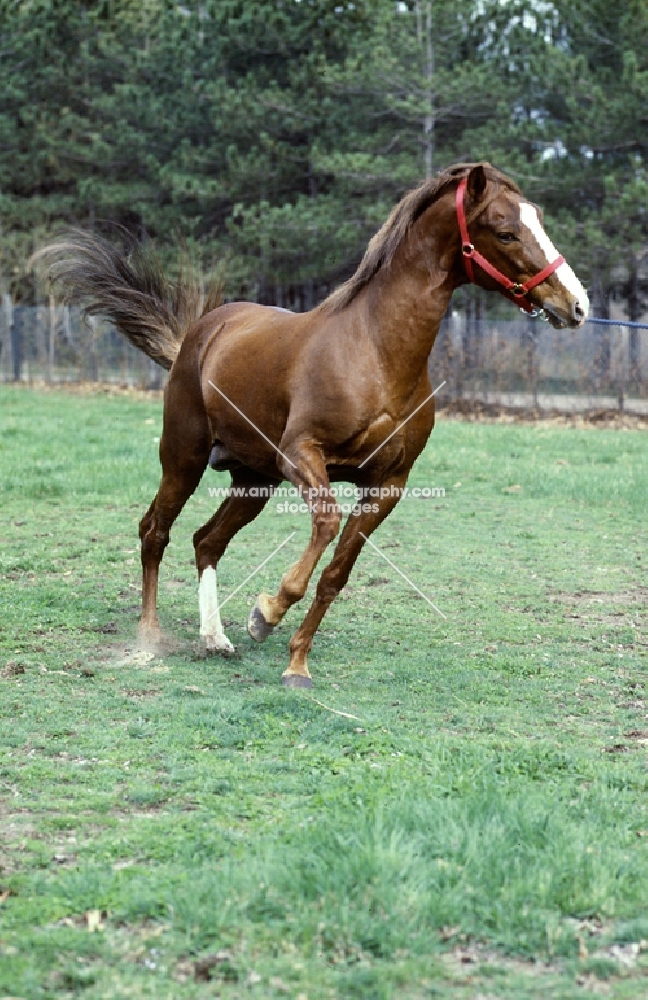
[365,198,458,390]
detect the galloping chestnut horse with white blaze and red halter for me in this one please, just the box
[41,163,589,687]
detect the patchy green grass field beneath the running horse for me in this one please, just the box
[0,387,648,1000]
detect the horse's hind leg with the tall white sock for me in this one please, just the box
[194,472,272,656]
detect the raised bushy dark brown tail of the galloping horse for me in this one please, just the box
[32,229,222,369]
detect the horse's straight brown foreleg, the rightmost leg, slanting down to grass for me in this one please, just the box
[282,476,407,687]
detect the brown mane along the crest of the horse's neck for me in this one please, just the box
[322,163,521,313]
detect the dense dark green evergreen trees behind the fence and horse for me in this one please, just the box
[0,0,648,319]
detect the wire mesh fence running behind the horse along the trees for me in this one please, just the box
[0,296,648,415]
